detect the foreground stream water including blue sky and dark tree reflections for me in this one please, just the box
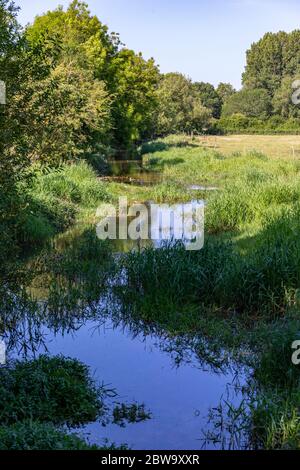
[0,229,245,450]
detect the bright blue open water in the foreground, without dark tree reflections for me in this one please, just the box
[31,321,241,450]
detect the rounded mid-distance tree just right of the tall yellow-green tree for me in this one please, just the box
[157,73,211,135]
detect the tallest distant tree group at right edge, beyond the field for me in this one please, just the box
[217,30,300,133]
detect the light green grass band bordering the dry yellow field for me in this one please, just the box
[143,139,300,188]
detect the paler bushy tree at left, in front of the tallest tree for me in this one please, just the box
[13,62,110,166]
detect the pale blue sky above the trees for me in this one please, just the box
[15,0,300,88]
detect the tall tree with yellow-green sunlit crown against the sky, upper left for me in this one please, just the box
[26,0,159,159]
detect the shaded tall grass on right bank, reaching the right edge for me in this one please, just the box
[116,206,300,319]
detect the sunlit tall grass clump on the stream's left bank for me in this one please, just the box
[19,162,111,248]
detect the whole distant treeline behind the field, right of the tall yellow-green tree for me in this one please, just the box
[156,30,300,134]
